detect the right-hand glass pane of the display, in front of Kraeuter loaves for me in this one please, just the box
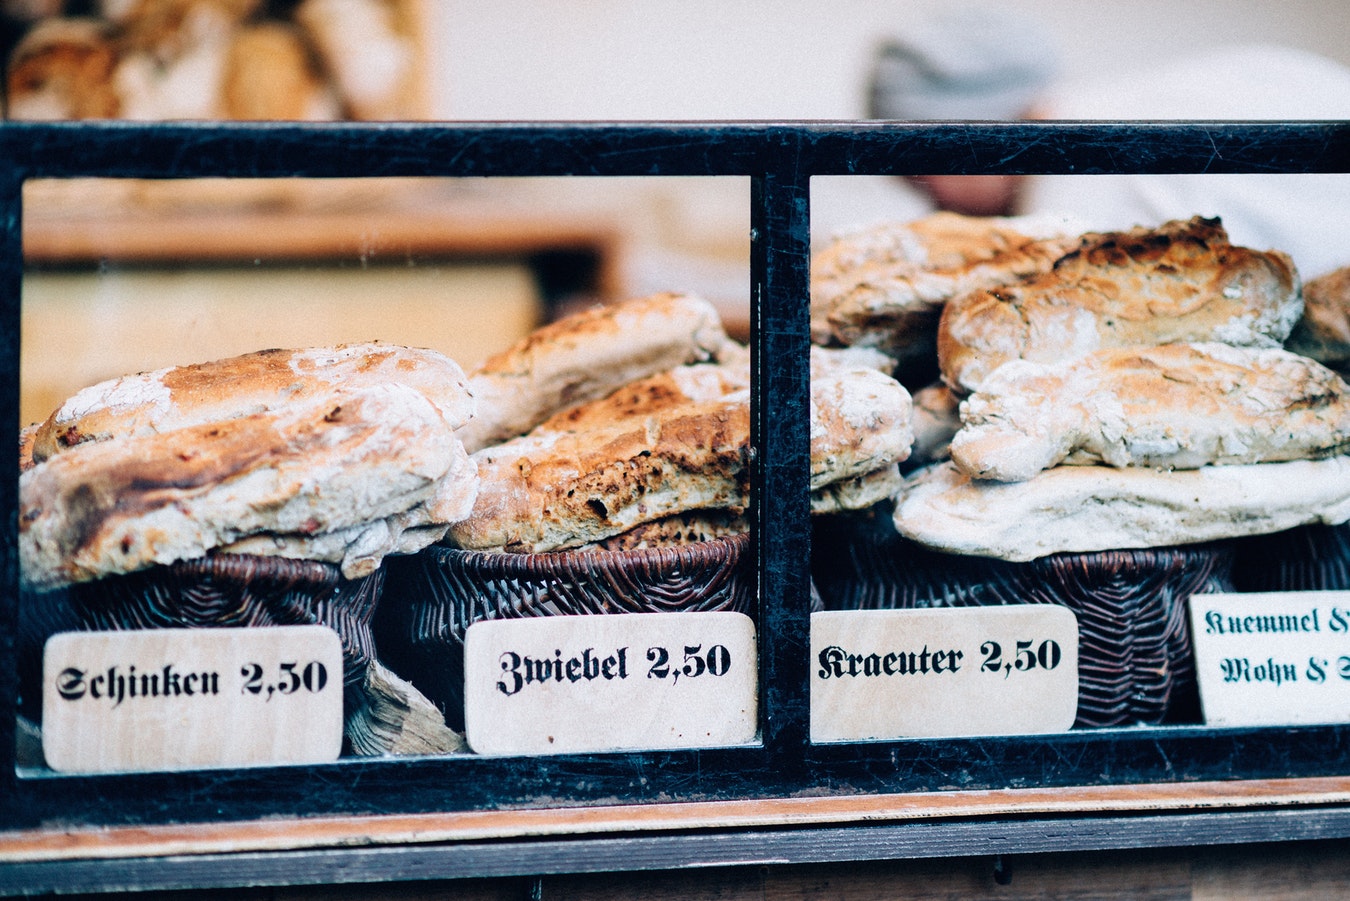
[811,176,1350,740]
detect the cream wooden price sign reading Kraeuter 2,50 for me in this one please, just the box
[811,604,1079,742]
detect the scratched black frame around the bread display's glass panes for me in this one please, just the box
[0,122,1350,854]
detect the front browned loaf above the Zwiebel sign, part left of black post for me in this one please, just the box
[448,390,751,552]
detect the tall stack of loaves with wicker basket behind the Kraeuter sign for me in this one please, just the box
[822,217,1350,725]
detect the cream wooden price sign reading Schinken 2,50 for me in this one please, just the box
[42,625,343,773]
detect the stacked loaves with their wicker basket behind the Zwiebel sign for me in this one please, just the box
[379,294,911,725]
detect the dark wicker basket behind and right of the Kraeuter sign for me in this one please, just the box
[811,521,1233,728]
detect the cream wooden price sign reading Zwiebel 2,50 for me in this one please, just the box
[464,613,759,754]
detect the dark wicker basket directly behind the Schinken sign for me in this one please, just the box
[19,554,385,719]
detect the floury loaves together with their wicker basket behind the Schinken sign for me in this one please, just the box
[19,344,478,752]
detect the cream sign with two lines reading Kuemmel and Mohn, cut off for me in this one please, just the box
[1189,592,1350,725]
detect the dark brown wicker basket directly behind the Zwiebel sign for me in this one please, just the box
[375,534,755,729]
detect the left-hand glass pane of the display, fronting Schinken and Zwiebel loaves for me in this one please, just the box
[19,178,759,773]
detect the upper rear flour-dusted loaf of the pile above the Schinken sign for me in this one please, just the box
[32,343,474,462]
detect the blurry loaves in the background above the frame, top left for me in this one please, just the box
[7,0,428,120]
